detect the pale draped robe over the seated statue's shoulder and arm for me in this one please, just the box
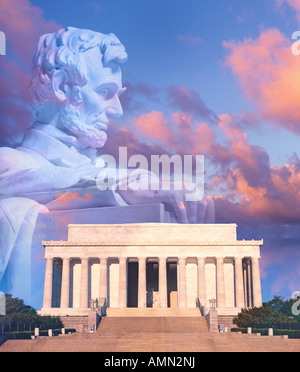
[0,125,126,300]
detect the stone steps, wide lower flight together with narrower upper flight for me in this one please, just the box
[0,314,300,353]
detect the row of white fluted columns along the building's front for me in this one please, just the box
[43,257,262,309]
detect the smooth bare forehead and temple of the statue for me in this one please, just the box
[84,47,122,86]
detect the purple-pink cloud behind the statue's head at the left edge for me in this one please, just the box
[0,0,61,145]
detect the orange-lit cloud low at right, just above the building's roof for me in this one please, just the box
[214,157,300,224]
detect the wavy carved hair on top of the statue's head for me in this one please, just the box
[30,27,127,104]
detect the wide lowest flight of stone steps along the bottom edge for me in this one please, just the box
[0,332,300,352]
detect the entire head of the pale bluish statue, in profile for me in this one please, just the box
[31,27,127,148]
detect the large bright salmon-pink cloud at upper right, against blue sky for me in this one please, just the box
[224,29,300,134]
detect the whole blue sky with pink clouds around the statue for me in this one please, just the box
[0,0,300,301]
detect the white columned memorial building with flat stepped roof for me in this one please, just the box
[41,223,263,316]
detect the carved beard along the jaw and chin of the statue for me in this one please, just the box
[59,105,107,149]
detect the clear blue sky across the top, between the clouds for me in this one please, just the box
[32,0,300,165]
